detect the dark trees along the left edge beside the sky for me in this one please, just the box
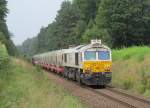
[0,0,17,56]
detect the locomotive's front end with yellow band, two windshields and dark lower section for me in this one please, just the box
[82,41,112,85]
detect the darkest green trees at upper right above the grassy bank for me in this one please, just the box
[96,0,150,47]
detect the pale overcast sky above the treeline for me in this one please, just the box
[7,0,64,45]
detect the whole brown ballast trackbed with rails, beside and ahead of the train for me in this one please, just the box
[45,70,150,108]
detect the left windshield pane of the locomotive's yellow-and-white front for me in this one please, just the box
[84,51,96,60]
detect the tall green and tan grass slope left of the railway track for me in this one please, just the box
[0,59,85,108]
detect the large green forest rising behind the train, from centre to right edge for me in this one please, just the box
[18,0,150,56]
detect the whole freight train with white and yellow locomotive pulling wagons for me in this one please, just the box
[32,40,112,86]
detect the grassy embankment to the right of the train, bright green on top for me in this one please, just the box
[112,47,150,97]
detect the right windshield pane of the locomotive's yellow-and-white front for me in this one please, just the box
[98,51,110,60]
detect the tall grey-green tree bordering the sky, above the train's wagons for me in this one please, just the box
[54,1,82,48]
